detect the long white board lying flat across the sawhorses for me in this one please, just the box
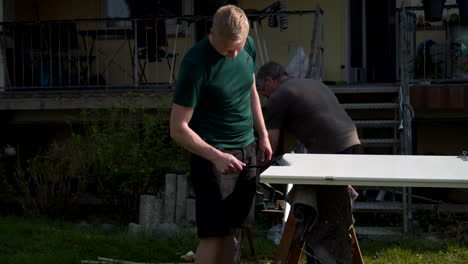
[260,154,468,188]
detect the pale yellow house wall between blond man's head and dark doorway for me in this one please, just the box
[240,0,347,81]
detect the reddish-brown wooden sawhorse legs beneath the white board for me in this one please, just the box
[274,212,364,264]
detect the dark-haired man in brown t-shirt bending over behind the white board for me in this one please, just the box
[256,62,360,263]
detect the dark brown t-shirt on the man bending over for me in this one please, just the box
[264,79,360,153]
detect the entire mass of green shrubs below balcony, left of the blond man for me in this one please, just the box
[10,103,188,221]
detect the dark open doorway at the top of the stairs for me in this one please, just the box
[365,0,396,83]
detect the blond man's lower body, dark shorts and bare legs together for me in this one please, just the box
[191,144,255,263]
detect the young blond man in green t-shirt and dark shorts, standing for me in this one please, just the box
[170,5,272,264]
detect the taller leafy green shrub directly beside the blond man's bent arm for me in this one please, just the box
[87,109,187,221]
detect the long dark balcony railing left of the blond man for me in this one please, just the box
[0,18,192,90]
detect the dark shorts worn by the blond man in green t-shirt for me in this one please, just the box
[190,143,256,238]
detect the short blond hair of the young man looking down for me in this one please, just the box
[211,5,250,42]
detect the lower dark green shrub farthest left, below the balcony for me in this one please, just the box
[14,134,91,216]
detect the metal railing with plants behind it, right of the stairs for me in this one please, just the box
[397,5,468,83]
